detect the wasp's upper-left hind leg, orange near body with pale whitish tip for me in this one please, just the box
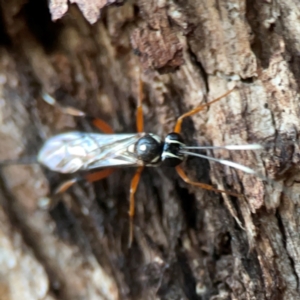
[42,93,114,133]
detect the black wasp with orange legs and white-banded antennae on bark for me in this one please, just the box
[37,80,262,245]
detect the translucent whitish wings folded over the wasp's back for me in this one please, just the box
[37,132,144,173]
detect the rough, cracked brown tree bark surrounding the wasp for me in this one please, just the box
[0,0,300,300]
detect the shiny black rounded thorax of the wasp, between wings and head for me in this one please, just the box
[135,134,163,164]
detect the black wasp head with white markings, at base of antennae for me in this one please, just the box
[161,132,185,167]
